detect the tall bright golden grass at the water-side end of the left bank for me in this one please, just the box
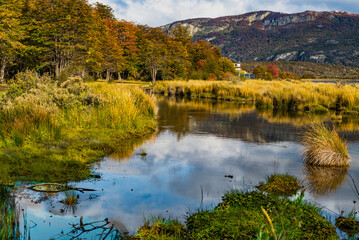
[67,83,157,131]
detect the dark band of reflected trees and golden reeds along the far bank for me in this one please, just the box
[157,97,359,143]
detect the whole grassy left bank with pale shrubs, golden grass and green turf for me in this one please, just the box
[0,73,157,183]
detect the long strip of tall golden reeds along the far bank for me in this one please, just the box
[155,80,359,115]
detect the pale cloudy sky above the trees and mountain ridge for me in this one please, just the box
[89,0,359,27]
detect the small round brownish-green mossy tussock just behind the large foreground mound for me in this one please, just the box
[257,174,301,197]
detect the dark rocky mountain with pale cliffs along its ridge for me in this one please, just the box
[162,11,359,67]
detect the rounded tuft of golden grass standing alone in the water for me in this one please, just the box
[302,123,350,167]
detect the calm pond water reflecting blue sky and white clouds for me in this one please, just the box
[8,98,359,240]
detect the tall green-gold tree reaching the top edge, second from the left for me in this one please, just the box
[30,0,92,77]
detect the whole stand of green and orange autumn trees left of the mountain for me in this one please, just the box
[0,0,234,83]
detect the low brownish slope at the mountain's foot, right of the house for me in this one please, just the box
[241,61,359,80]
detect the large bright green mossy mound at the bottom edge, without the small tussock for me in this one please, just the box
[187,192,337,239]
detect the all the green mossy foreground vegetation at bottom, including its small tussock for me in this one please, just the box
[129,174,338,239]
